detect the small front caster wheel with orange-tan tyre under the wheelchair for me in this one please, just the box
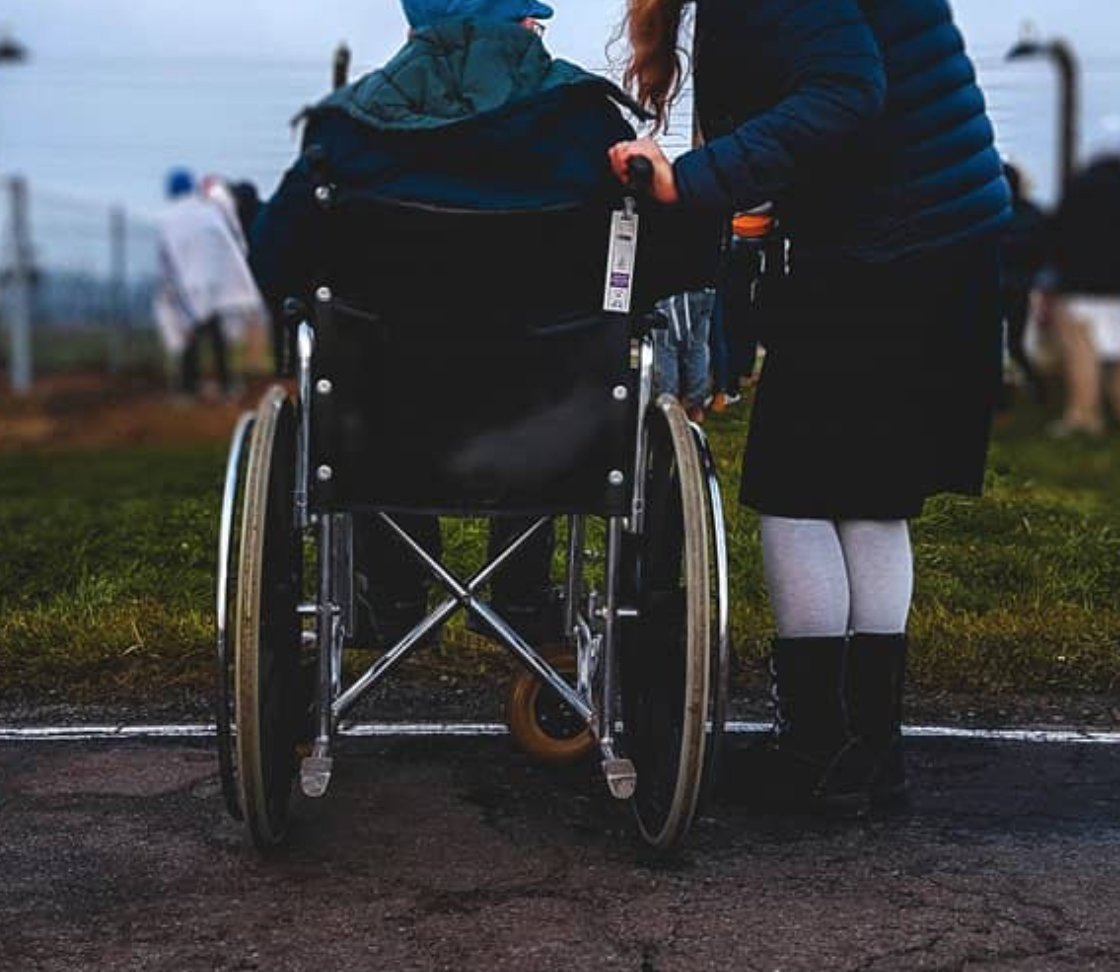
[505,645,595,766]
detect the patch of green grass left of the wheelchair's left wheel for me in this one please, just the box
[0,446,223,700]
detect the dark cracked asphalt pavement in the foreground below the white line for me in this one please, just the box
[0,739,1120,972]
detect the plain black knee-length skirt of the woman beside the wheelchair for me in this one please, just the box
[740,241,1002,520]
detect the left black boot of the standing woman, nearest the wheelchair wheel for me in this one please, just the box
[731,637,867,811]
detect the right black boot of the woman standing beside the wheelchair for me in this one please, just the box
[846,634,906,804]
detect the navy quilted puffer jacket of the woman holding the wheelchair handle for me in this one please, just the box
[675,0,1010,261]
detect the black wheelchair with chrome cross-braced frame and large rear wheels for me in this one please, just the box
[216,163,730,851]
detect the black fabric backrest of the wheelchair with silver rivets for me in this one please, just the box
[302,196,703,515]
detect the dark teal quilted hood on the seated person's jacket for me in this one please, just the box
[312,19,646,131]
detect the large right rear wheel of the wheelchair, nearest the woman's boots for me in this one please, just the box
[619,398,711,851]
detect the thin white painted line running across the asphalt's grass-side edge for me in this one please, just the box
[0,722,1120,746]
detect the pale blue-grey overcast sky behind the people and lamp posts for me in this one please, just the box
[0,0,1120,218]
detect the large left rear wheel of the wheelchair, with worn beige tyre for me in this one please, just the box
[234,386,309,849]
